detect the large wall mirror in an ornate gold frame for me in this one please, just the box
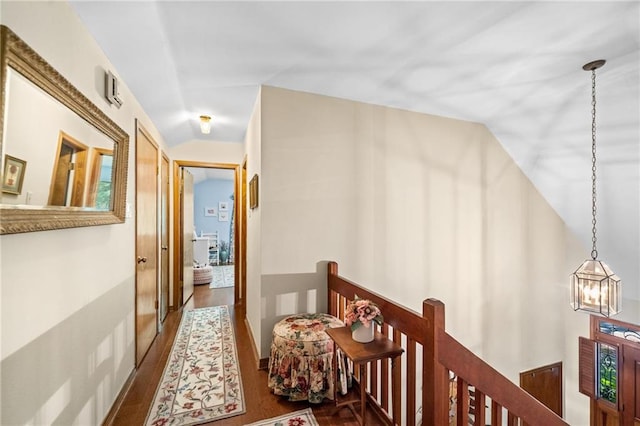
[0,25,129,234]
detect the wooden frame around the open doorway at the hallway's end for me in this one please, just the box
[172,160,244,310]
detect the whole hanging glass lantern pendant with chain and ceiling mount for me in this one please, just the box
[571,59,622,317]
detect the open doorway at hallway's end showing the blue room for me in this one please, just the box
[173,160,244,309]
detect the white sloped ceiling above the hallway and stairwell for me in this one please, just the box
[71,1,640,299]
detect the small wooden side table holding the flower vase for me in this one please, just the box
[326,324,404,426]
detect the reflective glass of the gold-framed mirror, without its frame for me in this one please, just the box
[2,69,114,211]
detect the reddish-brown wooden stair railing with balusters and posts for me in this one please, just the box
[327,262,568,426]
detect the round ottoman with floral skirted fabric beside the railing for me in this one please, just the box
[269,314,344,403]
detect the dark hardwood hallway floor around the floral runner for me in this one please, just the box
[106,285,370,426]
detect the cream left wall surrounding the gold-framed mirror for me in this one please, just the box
[0,1,164,425]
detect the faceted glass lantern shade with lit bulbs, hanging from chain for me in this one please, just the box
[571,259,622,317]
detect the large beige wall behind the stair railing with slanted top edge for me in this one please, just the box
[252,87,588,424]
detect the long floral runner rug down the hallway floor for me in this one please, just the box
[145,306,245,426]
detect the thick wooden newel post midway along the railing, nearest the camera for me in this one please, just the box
[422,299,449,426]
